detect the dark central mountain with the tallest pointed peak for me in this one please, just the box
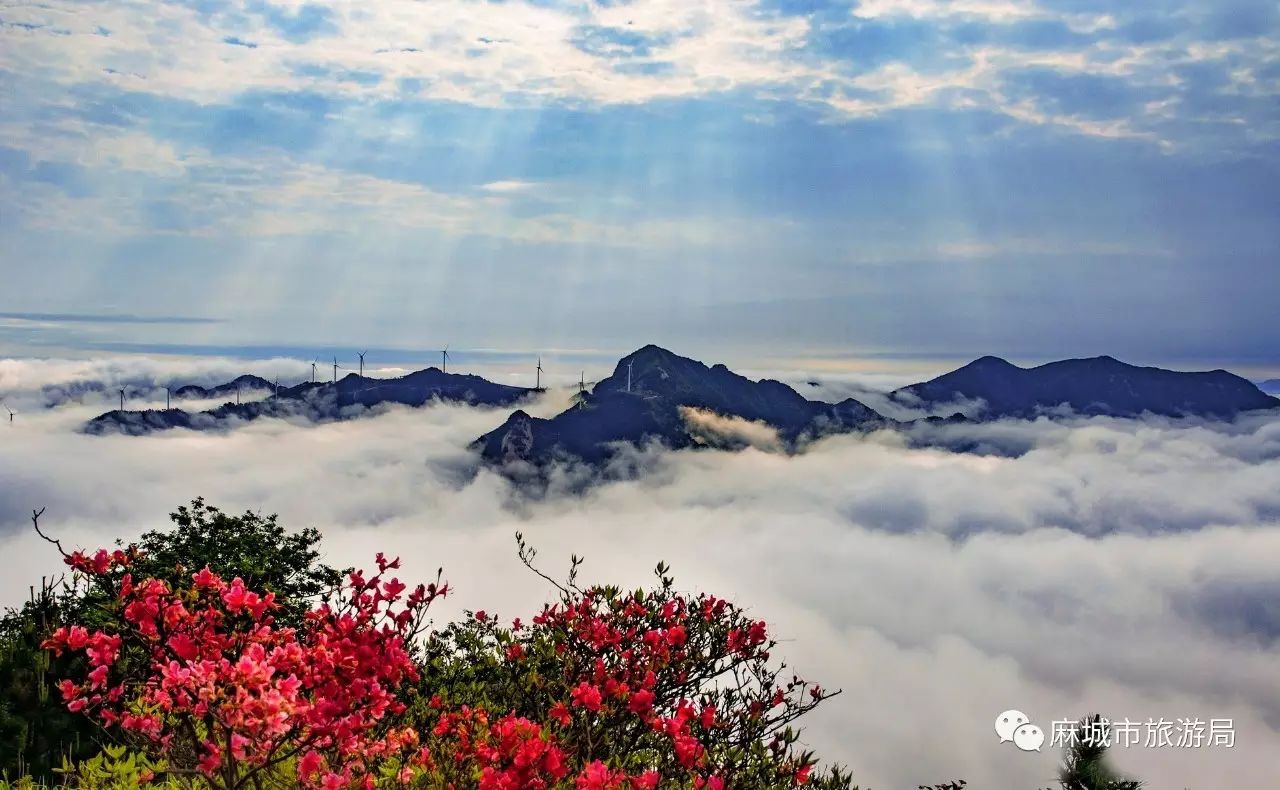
[474,346,886,464]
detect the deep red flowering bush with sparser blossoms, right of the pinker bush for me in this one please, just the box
[426,558,829,789]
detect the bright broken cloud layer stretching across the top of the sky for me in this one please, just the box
[0,0,1277,141]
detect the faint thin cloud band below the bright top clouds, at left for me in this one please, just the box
[0,122,794,248]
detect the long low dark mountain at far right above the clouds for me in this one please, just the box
[891,356,1280,419]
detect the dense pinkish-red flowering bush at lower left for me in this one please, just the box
[45,552,447,787]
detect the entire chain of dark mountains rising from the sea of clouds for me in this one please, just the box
[84,344,1280,453]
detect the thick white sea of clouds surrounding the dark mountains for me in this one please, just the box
[0,359,1280,790]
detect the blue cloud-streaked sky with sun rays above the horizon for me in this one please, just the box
[0,0,1280,373]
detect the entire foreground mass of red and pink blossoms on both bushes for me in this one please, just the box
[44,542,829,790]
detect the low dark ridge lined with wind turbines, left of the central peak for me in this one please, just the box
[84,367,532,435]
